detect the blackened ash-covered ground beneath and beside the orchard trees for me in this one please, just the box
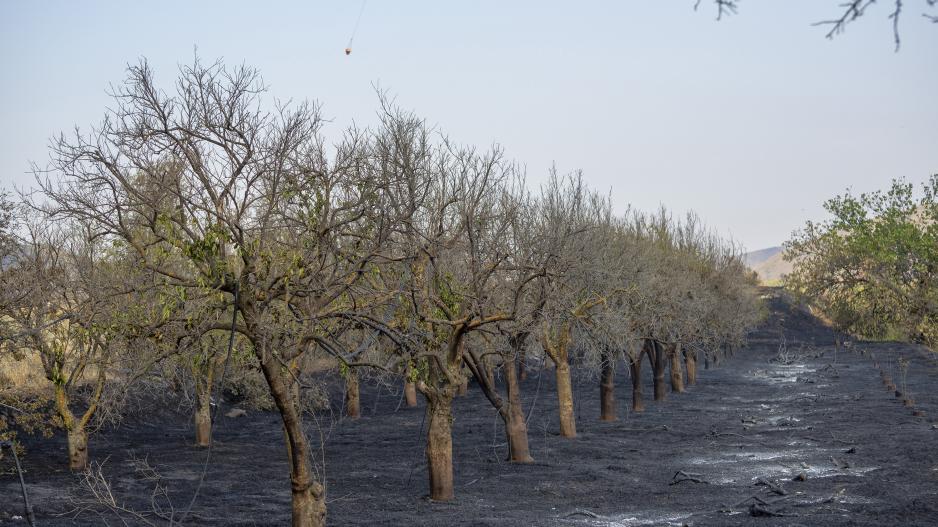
[0,291,938,526]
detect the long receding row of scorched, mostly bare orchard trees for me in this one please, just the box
[0,60,759,526]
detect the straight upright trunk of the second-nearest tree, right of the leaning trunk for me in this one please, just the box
[427,392,454,501]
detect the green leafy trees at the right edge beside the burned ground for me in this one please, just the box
[785,175,938,349]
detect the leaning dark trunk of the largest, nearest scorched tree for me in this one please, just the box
[258,349,326,527]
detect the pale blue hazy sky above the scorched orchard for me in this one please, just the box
[0,0,938,249]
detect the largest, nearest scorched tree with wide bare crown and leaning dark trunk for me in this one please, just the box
[40,59,416,526]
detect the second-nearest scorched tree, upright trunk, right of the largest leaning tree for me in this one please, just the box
[370,108,524,500]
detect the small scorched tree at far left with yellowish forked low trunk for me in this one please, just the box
[3,221,138,470]
